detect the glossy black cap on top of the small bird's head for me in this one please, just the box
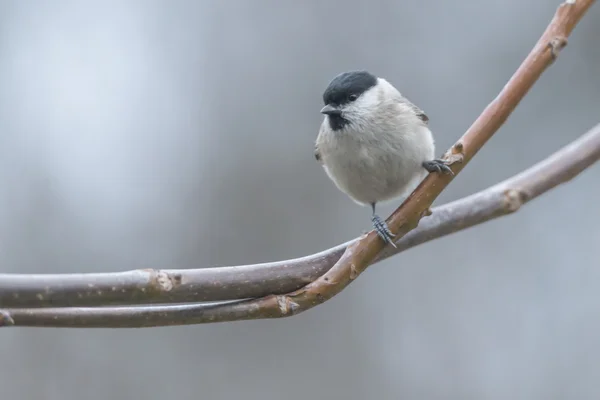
[323,71,377,105]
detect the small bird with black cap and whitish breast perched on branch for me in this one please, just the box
[315,71,452,247]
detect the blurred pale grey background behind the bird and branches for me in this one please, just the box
[0,0,600,400]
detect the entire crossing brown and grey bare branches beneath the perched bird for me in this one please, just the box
[0,0,600,326]
